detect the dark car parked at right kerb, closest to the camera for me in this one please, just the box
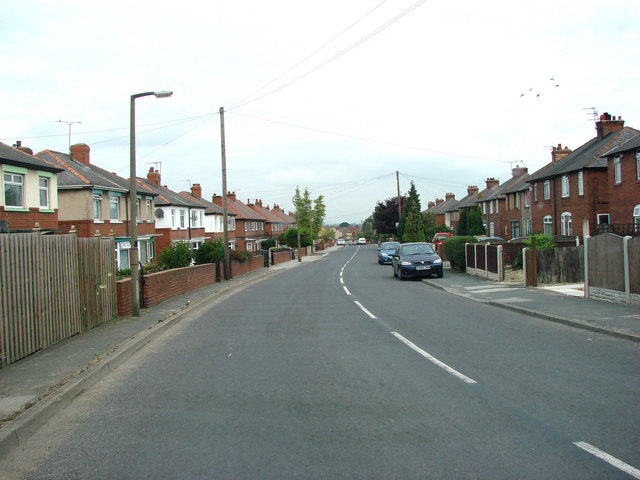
[391,242,442,280]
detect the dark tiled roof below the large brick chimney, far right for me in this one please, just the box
[527,127,638,183]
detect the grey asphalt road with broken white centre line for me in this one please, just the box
[0,246,640,479]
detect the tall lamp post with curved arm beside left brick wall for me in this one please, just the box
[129,91,173,317]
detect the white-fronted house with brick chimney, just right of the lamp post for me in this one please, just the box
[137,167,206,252]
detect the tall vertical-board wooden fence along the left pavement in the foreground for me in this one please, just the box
[0,233,117,367]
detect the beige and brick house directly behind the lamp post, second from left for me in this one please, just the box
[36,143,156,268]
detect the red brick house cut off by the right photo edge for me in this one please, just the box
[603,133,640,235]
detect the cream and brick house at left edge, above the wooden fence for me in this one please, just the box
[0,142,63,233]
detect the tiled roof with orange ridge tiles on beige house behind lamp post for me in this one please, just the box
[36,150,155,195]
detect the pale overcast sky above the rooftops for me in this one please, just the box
[0,0,640,224]
